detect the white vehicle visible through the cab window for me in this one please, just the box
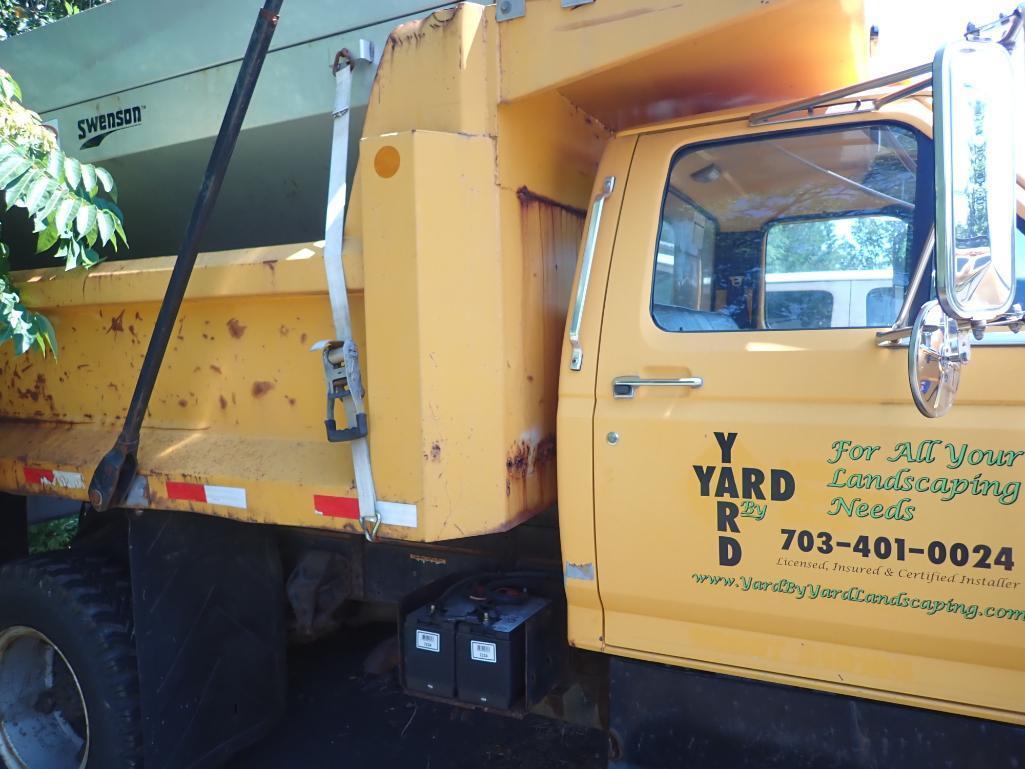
[765,270,904,329]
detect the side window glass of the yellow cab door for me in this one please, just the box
[651,124,919,332]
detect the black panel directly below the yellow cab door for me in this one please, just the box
[609,657,1025,769]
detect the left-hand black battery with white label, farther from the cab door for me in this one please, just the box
[403,606,456,698]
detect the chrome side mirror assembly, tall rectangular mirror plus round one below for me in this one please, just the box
[907,34,1025,417]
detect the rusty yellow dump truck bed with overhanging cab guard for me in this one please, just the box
[0,0,881,541]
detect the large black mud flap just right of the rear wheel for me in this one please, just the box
[129,512,286,769]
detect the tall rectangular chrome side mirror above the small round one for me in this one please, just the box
[933,42,1016,322]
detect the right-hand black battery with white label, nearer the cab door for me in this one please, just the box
[455,596,550,711]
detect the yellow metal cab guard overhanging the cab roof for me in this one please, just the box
[500,0,869,130]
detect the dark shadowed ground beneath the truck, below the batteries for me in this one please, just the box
[227,625,606,769]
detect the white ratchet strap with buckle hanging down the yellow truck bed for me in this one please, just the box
[315,51,381,541]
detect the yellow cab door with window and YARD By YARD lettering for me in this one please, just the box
[593,114,1025,723]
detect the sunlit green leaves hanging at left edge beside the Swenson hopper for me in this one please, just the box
[0,70,127,355]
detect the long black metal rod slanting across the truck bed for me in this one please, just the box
[89,0,283,510]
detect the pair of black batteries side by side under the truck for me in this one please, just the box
[403,582,562,711]
